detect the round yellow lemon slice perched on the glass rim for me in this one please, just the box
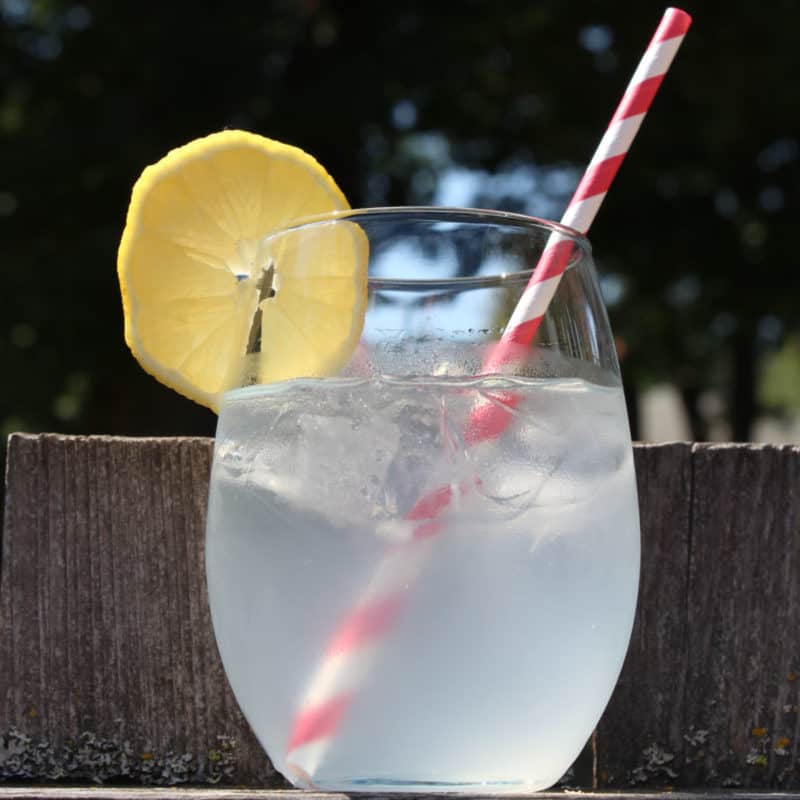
[117,130,368,410]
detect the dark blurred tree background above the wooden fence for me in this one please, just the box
[0,0,800,454]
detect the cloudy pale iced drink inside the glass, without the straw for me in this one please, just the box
[207,378,639,791]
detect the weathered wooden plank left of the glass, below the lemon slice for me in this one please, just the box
[0,435,284,786]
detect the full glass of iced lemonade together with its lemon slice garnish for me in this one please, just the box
[118,131,639,792]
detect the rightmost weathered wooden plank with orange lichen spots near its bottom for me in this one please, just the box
[685,445,800,789]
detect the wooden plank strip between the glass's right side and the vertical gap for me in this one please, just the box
[595,444,692,787]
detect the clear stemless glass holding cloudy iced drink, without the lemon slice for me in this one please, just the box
[207,208,639,792]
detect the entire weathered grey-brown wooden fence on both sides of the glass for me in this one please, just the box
[0,435,800,788]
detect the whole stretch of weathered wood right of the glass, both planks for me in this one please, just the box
[596,445,800,789]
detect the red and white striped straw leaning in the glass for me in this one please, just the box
[287,8,692,785]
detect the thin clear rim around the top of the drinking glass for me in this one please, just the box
[262,206,592,291]
